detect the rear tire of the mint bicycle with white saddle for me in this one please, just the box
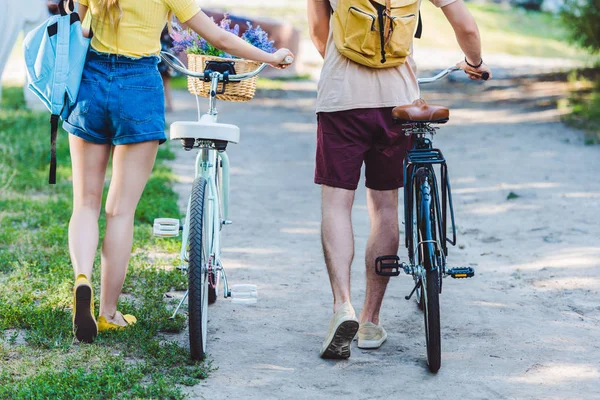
[188,178,209,360]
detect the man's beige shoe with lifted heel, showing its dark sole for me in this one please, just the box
[321,303,358,359]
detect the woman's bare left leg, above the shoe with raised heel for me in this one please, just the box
[69,135,111,279]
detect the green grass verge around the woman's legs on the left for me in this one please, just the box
[0,87,212,399]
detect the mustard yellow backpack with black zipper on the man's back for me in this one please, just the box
[332,0,421,68]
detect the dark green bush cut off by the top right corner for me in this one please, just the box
[561,0,600,53]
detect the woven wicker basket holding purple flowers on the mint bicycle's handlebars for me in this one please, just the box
[188,54,261,101]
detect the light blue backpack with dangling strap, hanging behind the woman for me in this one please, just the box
[23,0,90,184]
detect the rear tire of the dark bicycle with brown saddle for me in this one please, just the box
[417,171,441,373]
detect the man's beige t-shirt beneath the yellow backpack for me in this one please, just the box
[317,0,456,112]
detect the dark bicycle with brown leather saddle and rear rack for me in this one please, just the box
[375,67,489,373]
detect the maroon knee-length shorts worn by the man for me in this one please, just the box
[315,107,412,190]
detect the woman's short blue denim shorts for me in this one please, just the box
[63,50,167,145]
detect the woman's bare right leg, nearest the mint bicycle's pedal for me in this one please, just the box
[100,141,158,325]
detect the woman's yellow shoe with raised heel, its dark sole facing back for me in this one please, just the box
[73,274,98,343]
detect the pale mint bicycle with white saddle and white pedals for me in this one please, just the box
[154,52,292,360]
